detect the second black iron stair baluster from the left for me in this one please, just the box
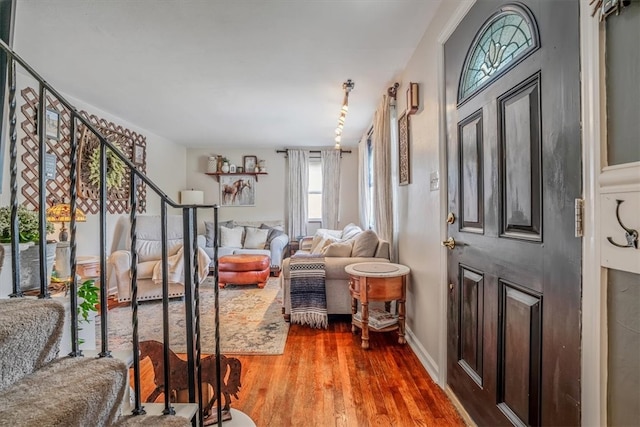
[38,82,51,298]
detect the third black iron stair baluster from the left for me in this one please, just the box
[69,110,82,357]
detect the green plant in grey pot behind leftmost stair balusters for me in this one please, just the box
[0,205,56,293]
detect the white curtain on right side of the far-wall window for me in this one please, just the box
[320,149,341,230]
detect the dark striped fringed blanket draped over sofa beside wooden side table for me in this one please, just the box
[289,256,329,329]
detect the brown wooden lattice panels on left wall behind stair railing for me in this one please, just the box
[20,88,147,214]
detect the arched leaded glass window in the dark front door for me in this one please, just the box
[458,5,540,102]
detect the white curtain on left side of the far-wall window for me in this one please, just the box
[287,150,309,240]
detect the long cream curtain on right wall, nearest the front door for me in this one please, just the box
[373,94,395,261]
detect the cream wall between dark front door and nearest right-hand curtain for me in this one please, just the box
[390,0,461,385]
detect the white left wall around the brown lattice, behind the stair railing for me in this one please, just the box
[0,73,186,256]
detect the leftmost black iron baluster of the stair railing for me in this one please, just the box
[7,53,24,298]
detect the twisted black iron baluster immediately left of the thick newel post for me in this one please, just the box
[160,202,176,415]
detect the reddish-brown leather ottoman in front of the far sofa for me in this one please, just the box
[218,254,271,288]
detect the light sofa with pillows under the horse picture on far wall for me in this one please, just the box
[198,220,289,276]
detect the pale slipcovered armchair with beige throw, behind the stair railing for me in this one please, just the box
[107,215,211,302]
